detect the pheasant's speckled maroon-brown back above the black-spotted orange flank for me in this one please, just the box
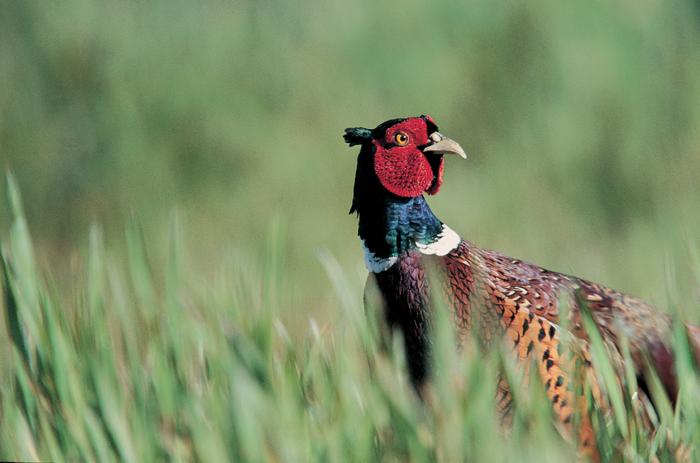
[445,241,700,399]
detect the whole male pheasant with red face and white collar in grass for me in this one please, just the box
[344,116,700,455]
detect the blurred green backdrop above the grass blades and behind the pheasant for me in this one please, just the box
[0,0,700,318]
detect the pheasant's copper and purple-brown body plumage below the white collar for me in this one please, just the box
[372,240,700,456]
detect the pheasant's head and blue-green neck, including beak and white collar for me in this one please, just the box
[344,116,466,271]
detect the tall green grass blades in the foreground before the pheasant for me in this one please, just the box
[0,179,700,462]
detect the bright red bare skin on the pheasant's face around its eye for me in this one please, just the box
[373,117,443,198]
